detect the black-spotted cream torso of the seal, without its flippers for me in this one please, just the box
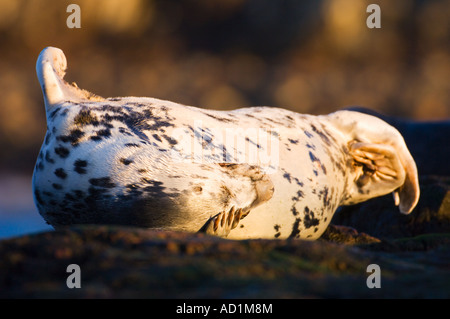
[33,101,345,238]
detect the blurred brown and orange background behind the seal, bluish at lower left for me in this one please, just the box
[0,0,450,238]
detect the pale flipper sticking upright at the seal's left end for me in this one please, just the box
[36,47,104,111]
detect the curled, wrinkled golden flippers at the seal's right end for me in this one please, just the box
[329,111,420,214]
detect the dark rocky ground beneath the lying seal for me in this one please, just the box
[0,177,450,298]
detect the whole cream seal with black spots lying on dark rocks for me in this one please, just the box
[33,48,419,239]
